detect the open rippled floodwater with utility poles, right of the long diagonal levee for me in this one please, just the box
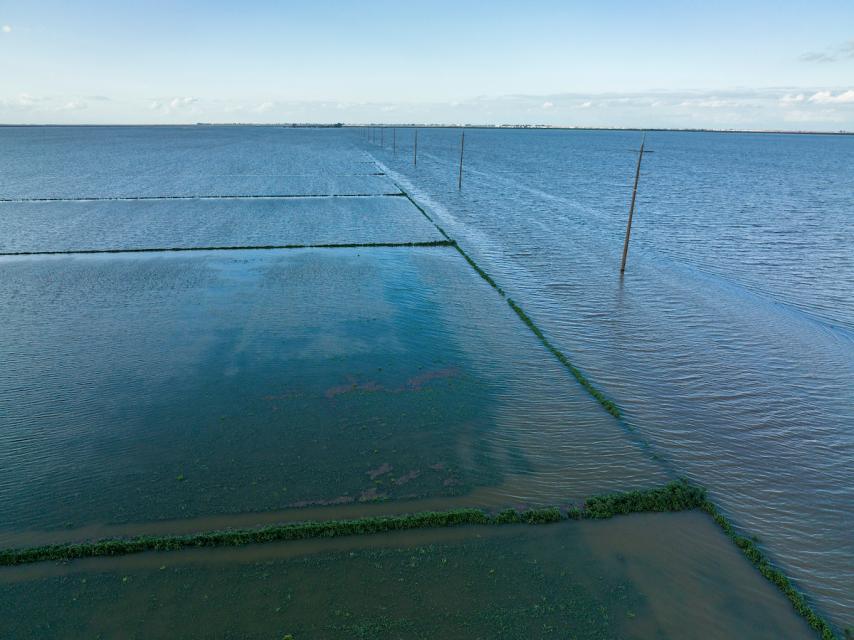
[372,129,854,625]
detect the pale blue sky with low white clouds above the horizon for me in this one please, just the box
[0,0,854,130]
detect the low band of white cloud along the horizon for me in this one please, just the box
[0,85,854,131]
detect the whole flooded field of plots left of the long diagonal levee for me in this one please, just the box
[0,127,844,639]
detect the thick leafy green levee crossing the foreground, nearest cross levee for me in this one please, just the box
[0,480,706,566]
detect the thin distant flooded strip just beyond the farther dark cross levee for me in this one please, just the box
[0,172,400,201]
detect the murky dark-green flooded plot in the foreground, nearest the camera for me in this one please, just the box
[0,512,814,640]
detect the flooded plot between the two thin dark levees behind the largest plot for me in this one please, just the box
[0,197,445,253]
